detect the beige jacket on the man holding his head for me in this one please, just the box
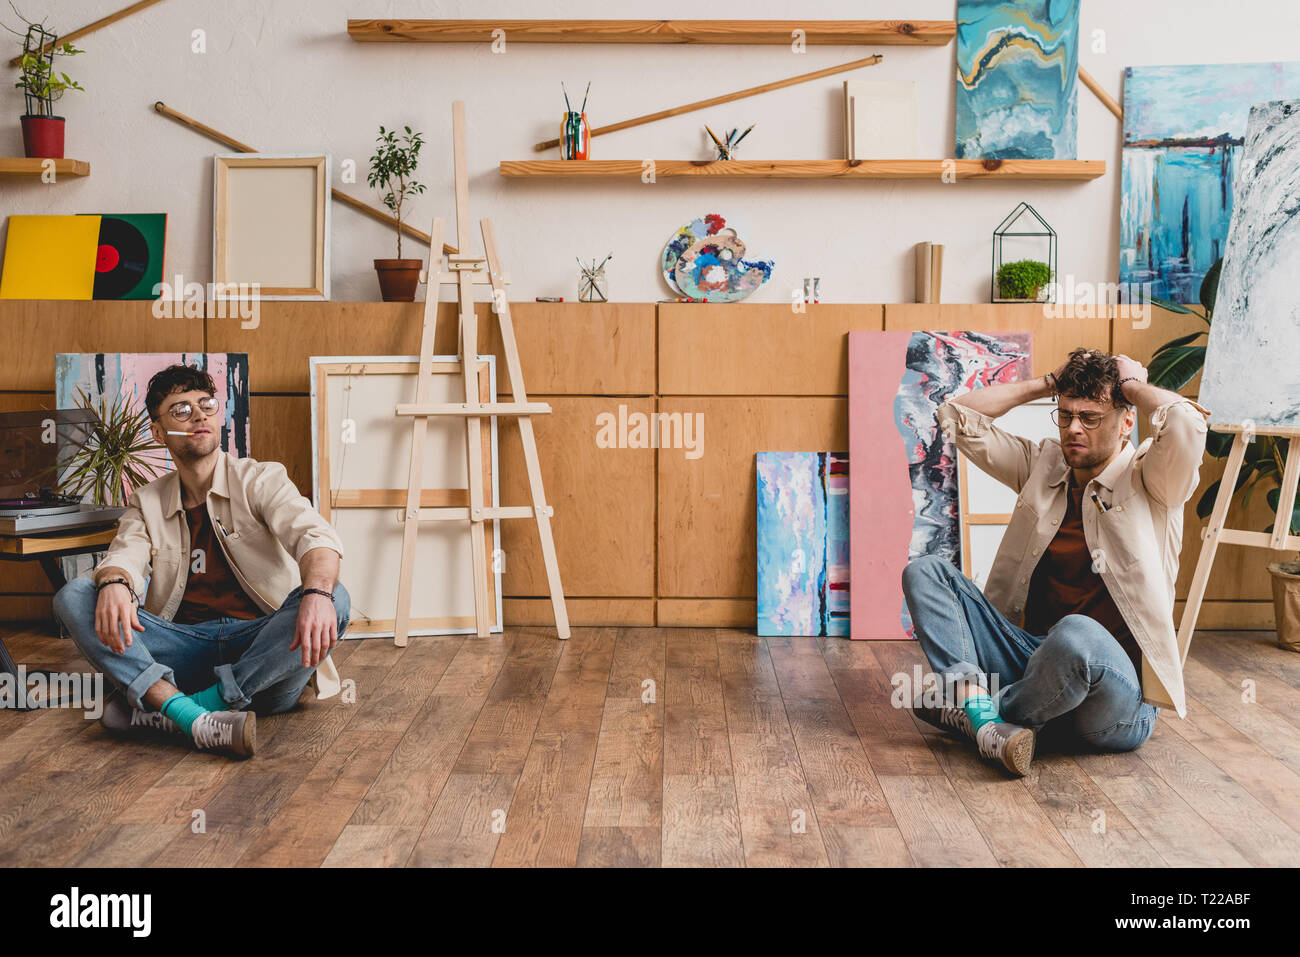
[937,398,1209,718]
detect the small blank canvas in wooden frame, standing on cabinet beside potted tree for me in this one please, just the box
[212,153,330,299]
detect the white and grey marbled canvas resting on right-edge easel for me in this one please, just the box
[1199,99,1300,429]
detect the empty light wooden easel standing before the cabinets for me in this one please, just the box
[393,100,569,645]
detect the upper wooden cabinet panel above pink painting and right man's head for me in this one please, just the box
[885,303,1110,376]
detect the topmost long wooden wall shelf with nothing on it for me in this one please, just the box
[347,20,957,47]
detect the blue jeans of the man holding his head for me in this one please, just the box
[902,555,1160,752]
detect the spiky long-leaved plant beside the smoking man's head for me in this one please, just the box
[59,389,165,505]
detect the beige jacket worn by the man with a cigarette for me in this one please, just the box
[100,451,343,698]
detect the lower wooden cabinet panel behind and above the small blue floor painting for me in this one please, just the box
[658,397,849,598]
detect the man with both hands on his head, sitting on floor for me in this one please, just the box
[902,348,1208,775]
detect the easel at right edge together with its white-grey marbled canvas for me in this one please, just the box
[1178,100,1300,662]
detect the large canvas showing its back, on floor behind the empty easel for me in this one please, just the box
[311,356,503,637]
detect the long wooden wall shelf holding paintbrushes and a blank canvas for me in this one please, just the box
[501,160,1106,181]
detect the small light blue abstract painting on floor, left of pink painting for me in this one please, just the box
[755,452,849,636]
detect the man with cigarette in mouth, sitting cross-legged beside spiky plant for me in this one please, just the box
[55,365,348,757]
